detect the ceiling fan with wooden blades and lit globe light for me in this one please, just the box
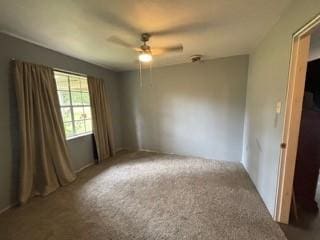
[108,33,183,63]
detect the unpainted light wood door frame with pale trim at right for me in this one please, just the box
[274,15,320,224]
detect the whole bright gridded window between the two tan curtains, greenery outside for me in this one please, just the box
[54,71,92,139]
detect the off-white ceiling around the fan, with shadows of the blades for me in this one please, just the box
[0,0,291,70]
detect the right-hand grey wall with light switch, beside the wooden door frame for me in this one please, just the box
[242,0,320,215]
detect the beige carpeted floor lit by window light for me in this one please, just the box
[0,152,286,240]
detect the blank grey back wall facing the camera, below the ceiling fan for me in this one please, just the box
[120,56,248,161]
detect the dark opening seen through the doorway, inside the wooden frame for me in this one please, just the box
[282,55,320,237]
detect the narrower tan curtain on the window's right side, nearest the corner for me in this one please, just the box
[88,77,115,162]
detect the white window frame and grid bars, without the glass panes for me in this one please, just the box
[54,70,93,140]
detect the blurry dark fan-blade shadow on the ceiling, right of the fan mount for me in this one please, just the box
[150,22,213,36]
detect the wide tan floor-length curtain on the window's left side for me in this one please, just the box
[13,61,75,203]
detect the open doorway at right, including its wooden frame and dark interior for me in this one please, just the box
[275,13,320,234]
